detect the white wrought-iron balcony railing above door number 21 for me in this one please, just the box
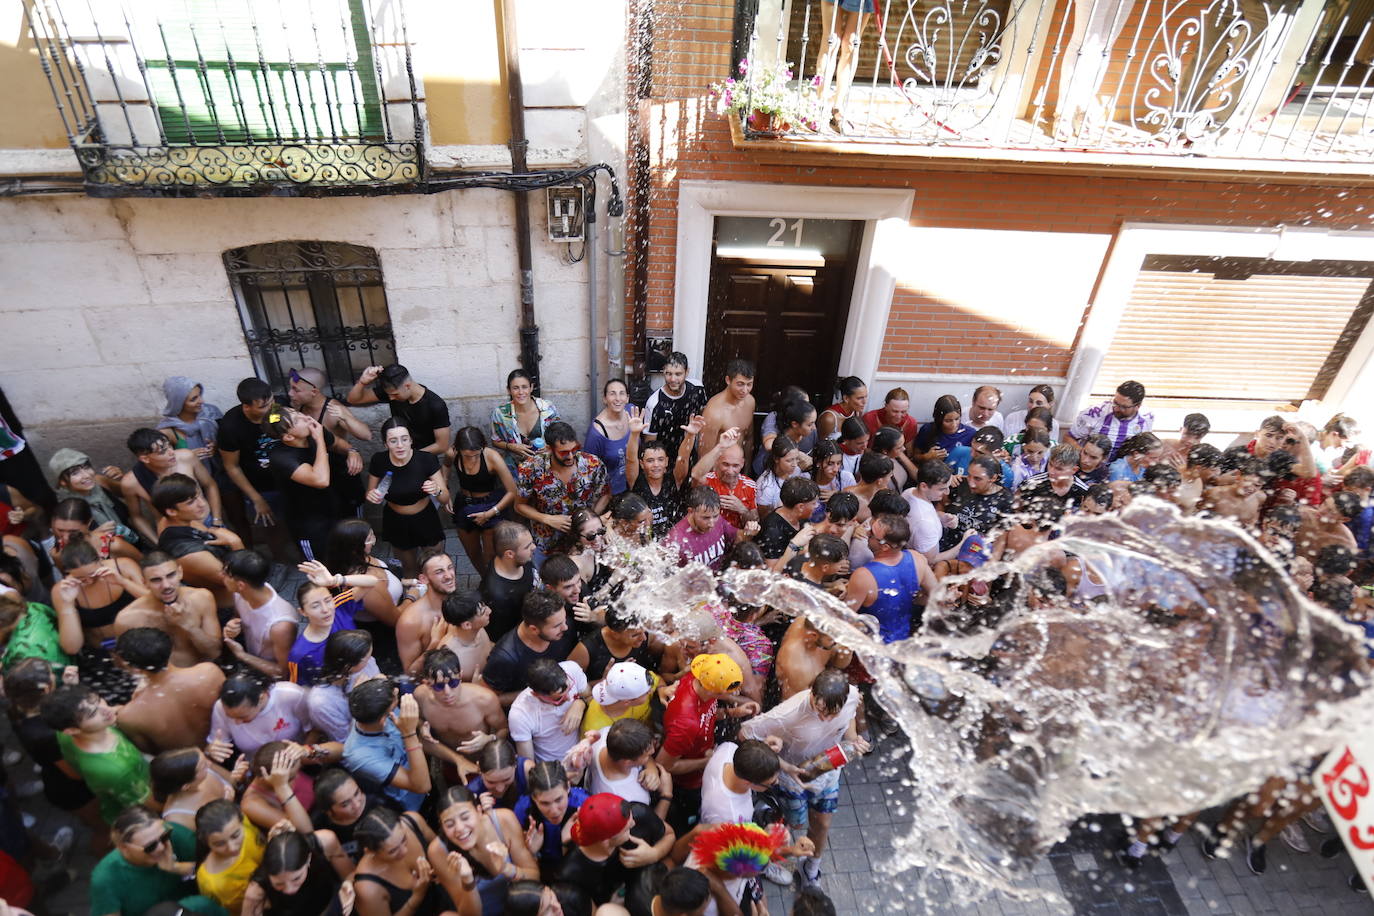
[734,0,1374,163]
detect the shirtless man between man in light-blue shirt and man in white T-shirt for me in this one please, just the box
[415,648,510,780]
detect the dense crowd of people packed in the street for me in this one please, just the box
[0,353,1374,916]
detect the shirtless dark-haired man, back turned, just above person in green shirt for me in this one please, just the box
[114,626,224,754]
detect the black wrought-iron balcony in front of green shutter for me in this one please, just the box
[25,0,423,196]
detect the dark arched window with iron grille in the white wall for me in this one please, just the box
[224,242,396,396]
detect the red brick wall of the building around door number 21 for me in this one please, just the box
[627,0,1374,375]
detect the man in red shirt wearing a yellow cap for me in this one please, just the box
[658,655,758,835]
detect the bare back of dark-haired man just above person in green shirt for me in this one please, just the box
[118,662,224,754]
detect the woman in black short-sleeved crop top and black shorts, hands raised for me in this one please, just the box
[367,417,448,577]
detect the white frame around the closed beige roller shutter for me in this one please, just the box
[1058,222,1374,422]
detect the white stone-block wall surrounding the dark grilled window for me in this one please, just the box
[0,191,589,461]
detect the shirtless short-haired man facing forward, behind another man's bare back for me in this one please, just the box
[114,549,224,667]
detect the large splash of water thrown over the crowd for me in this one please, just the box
[593,500,1374,902]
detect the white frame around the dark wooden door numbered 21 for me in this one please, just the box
[673,181,915,391]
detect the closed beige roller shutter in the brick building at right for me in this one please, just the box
[1092,255,1374,402]
